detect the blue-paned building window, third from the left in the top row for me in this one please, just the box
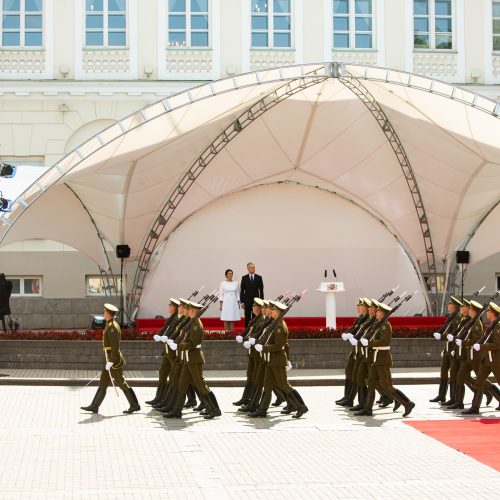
[168,0,209,48]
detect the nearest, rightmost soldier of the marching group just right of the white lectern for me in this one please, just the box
[355,303,415,417]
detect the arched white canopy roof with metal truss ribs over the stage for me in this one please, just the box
[0,63,500,316]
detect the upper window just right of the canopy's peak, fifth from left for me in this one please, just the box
[333,0,373,49]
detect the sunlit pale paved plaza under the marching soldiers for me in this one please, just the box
[0,385,500,499]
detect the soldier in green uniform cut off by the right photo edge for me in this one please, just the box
[462,302,500,415]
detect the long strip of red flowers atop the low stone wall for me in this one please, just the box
[0,327,436,340]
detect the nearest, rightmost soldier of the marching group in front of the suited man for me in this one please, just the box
[249,301,308,418]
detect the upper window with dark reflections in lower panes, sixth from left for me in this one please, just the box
[413,0,453,50]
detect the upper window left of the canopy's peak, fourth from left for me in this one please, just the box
[251,0,292,49]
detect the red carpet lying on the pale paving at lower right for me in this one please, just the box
[405,418,500,471]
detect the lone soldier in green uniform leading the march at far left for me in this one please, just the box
[82,304,141,413]
